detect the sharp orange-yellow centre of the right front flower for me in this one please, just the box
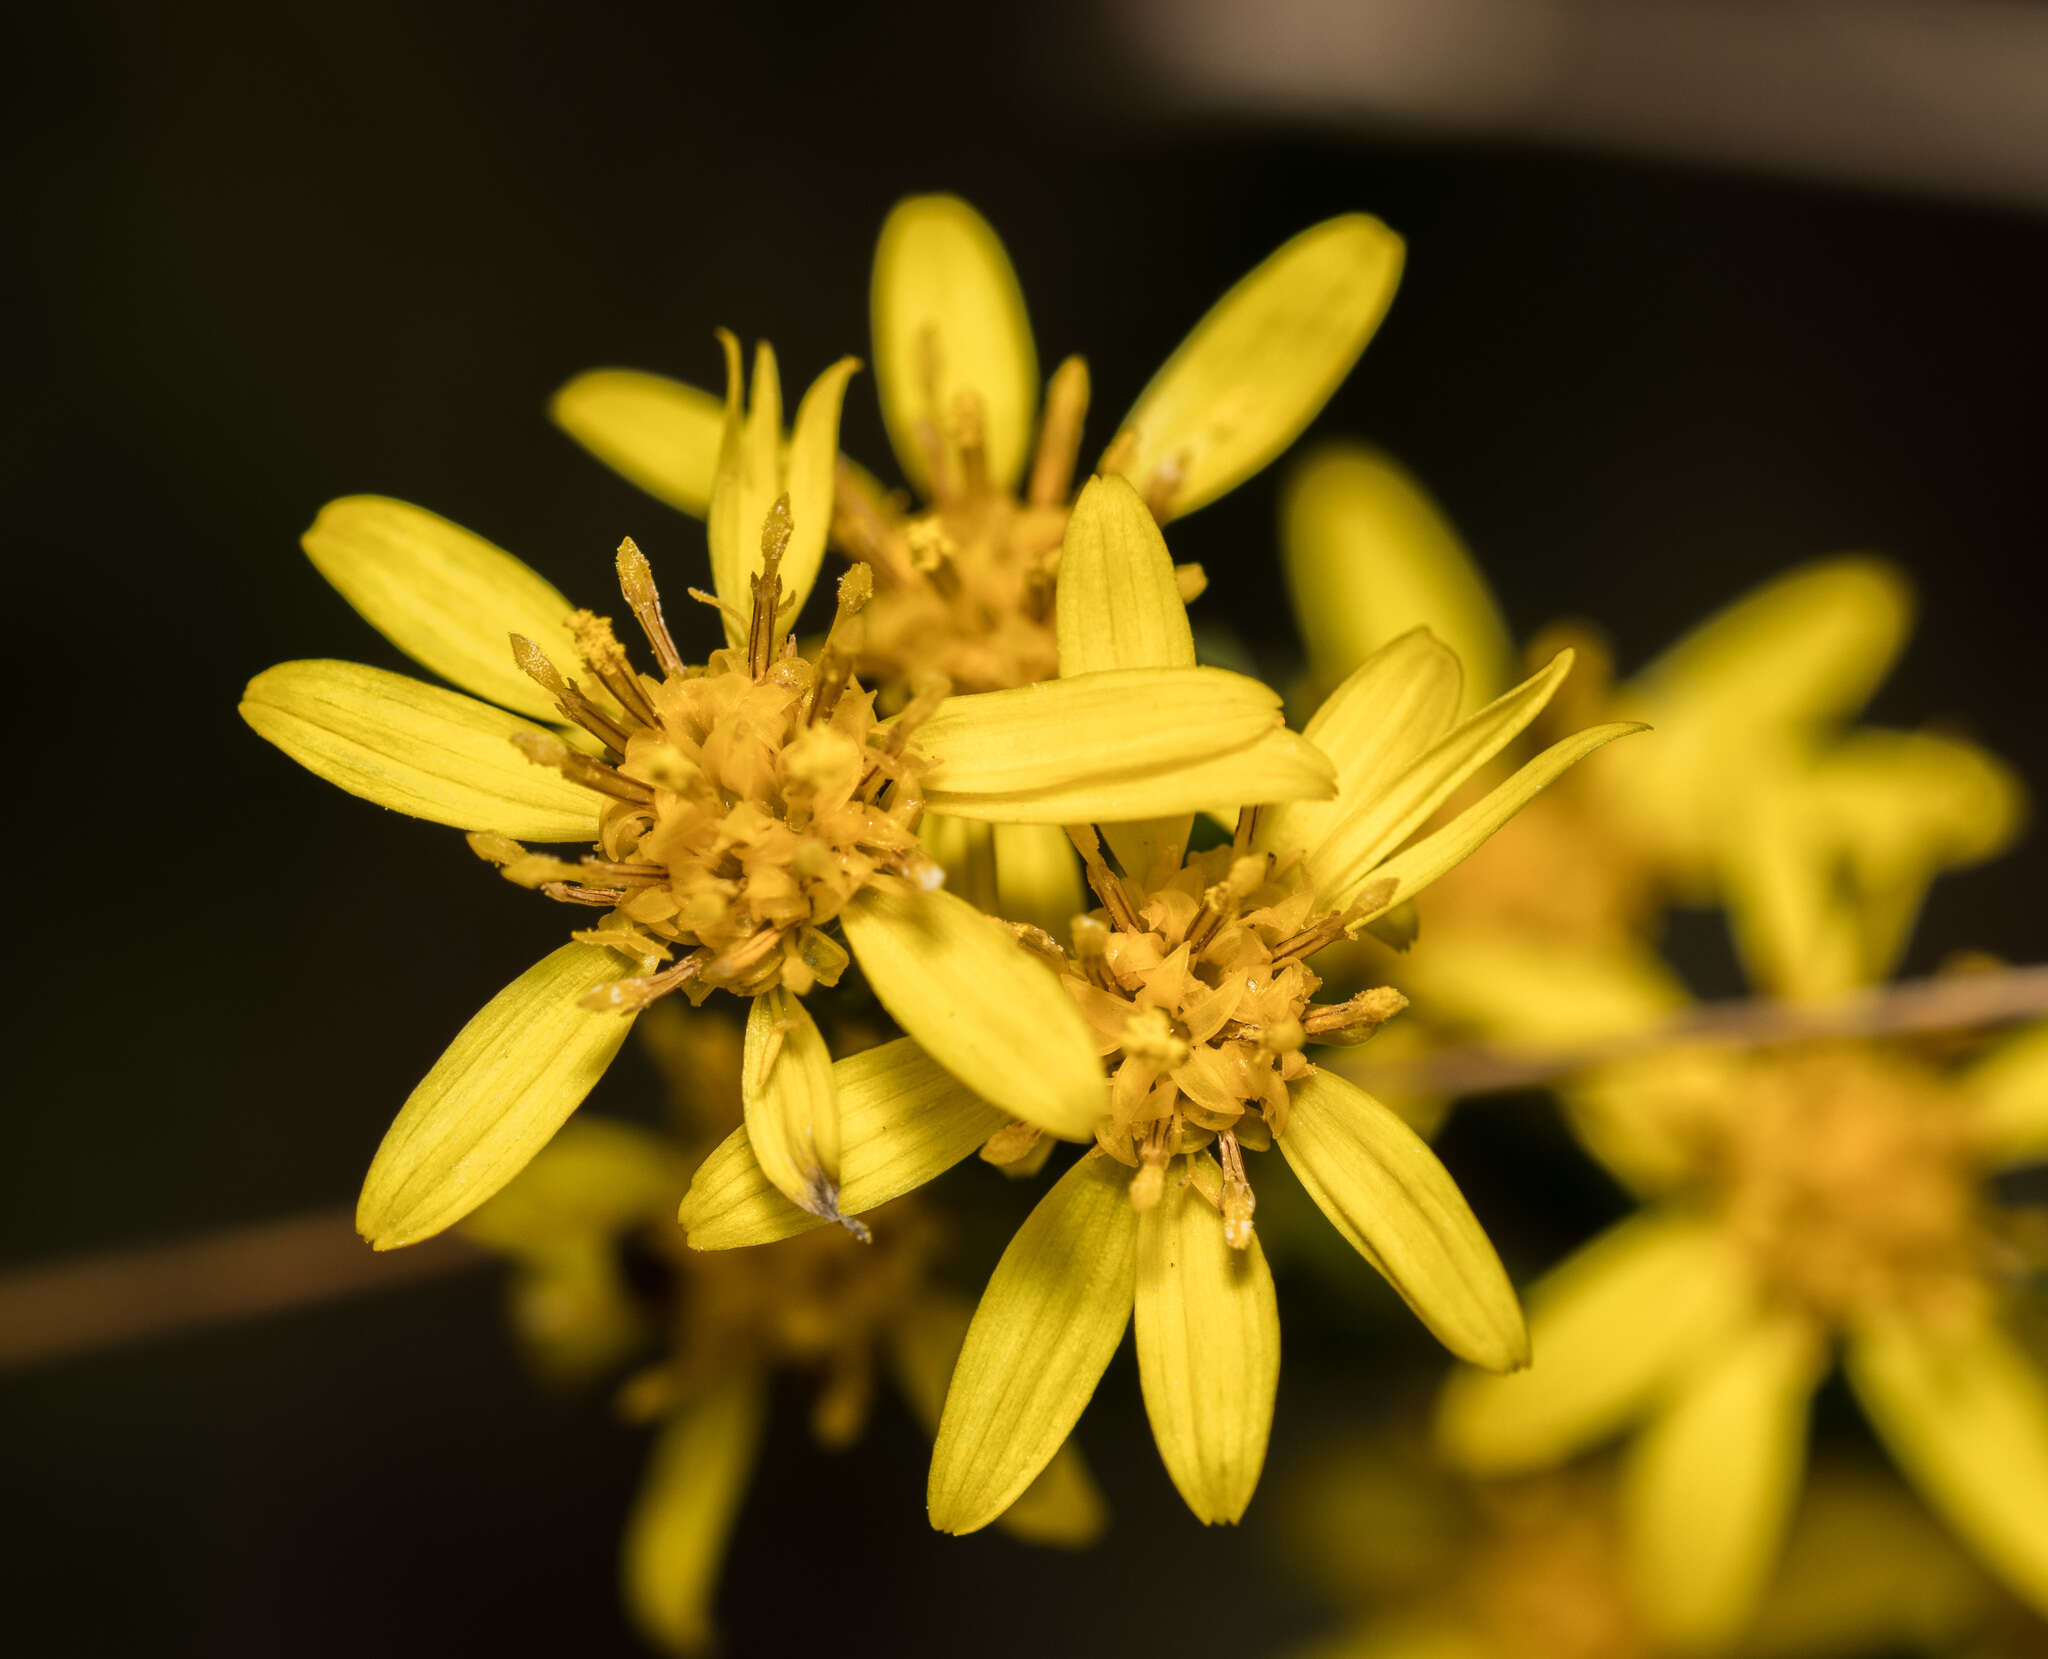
[1061,815,1407,1249]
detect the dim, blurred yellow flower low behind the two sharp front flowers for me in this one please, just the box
[463,1008,1104,1653]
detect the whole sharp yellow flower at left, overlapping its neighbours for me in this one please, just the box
[242,336,1331,1247]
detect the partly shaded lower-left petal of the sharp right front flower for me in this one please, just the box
[926,1151,1139,1532]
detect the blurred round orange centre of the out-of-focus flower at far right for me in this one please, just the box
[1710,1047,1993,1323]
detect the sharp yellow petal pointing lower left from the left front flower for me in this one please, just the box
[356,944,633,1249]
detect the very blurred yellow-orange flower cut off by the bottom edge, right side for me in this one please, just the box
[1280,1442,1995,1659]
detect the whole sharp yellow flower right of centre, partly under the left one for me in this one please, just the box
[682,464,1632,1532]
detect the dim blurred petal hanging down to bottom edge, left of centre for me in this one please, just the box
[621,1376,768,1655]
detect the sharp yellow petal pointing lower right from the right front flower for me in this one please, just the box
[1274,1071,1530,1370]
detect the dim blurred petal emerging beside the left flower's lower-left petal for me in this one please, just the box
[463,1116,688,1256]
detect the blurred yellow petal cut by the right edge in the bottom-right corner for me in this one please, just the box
[1847,1319,2048,1614]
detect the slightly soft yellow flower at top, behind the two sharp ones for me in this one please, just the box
[553,197,1403,690]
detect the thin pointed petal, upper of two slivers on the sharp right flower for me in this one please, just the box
[1305,651,1571,901]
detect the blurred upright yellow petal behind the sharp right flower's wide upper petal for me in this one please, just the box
[1280,444,1516,703]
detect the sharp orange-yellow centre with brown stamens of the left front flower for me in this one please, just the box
[469,498,946,1012]
